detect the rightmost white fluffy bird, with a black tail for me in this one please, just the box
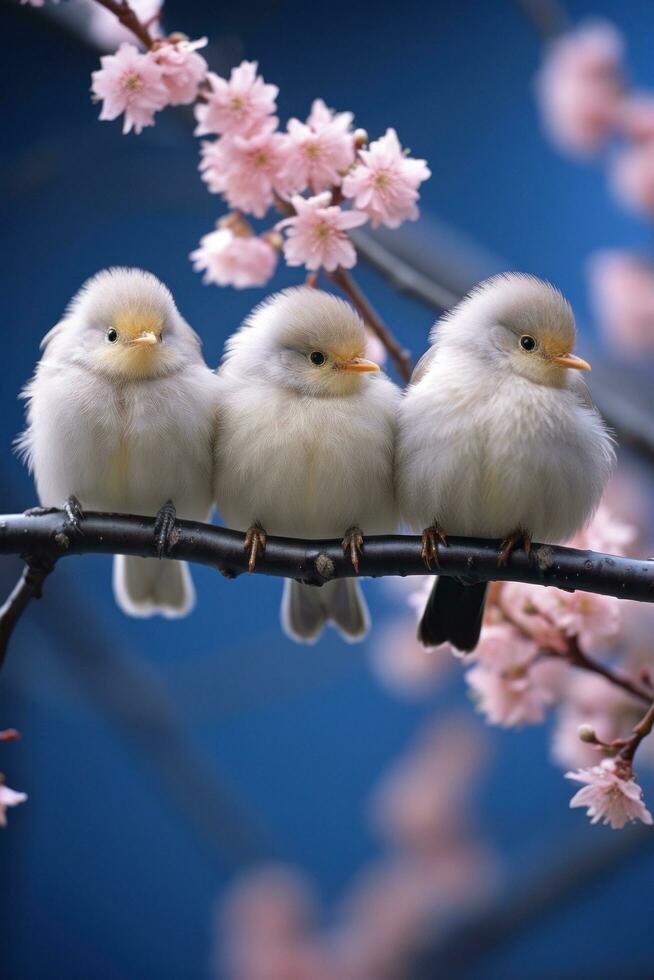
[397,273,615,651]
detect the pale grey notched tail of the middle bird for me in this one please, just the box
[282,578,370,643]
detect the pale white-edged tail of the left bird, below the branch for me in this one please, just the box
[114,555,195,619]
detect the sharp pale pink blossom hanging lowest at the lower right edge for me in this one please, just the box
[565,759,653,830]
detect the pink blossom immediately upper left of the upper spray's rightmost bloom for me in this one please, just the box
[284,99,354,194]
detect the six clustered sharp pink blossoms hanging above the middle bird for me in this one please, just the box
[191,61,430,288]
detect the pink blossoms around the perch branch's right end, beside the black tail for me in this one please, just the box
[373,507,654,828]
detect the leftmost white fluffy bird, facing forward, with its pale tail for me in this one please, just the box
[18,268,218,617]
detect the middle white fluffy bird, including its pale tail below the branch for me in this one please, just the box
[215,287,399,643]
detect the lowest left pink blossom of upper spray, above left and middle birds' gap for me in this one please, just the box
[190,228,277,289]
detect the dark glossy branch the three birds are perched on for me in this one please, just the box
[0,511,654,663]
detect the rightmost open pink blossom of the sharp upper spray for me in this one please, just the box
[343,129,431,228]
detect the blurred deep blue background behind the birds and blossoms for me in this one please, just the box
[0,0,654,980]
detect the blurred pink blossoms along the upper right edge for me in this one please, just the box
[536,20,654,354]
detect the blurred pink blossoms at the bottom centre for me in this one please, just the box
[215,716,497,980]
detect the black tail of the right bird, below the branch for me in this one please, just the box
[418,575,488,653]
